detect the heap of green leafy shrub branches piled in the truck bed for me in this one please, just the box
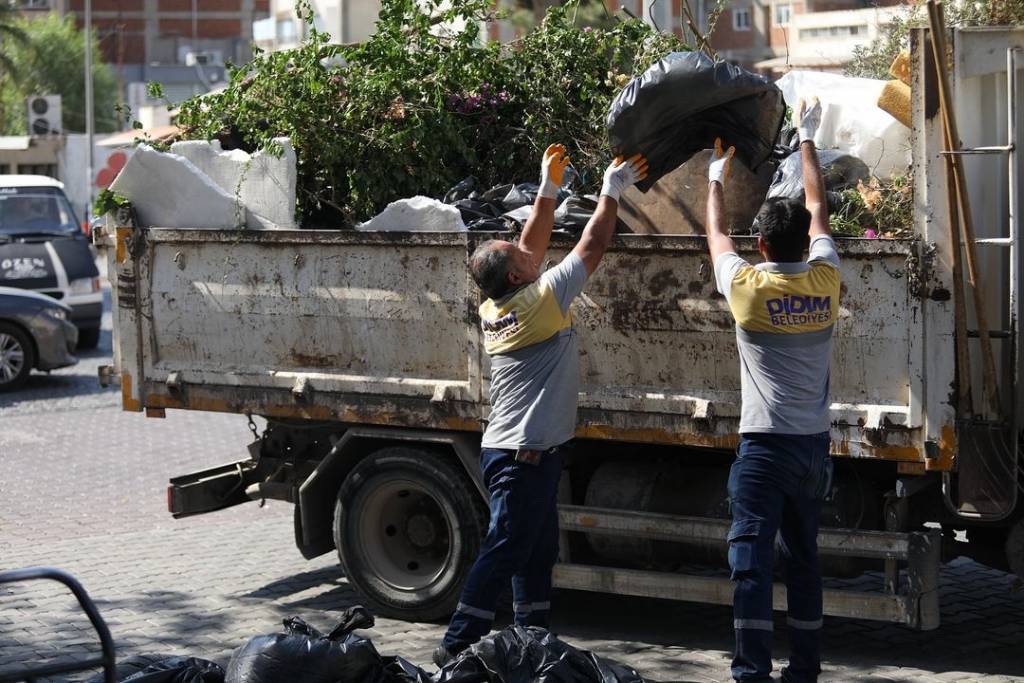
[177,0,688,227]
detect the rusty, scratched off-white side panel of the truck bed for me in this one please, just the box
[101,228,926,463]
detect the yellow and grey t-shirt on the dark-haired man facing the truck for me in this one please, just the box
[715,236,840,434]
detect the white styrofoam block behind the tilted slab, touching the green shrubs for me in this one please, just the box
[171,137,298,228]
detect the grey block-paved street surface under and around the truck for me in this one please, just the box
[0,286,1024,683]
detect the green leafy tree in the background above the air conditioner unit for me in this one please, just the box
[0,13,119,135]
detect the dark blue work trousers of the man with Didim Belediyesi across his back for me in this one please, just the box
[729,433,833,683]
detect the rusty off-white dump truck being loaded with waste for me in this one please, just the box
[94,29,1024,630]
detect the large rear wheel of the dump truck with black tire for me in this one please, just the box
[334,446,487,622]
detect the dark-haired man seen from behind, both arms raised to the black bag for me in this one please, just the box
[707,101,840,683]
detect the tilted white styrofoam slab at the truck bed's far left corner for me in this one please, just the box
[111,144,267,229]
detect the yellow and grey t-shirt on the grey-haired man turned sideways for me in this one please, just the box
[480,253,587,451]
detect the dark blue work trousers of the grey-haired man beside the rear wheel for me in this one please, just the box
[442,446,562,652]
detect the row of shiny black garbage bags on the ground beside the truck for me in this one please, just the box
[89,606,644,683]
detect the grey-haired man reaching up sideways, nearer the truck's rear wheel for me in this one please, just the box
[434,144,647,667]
